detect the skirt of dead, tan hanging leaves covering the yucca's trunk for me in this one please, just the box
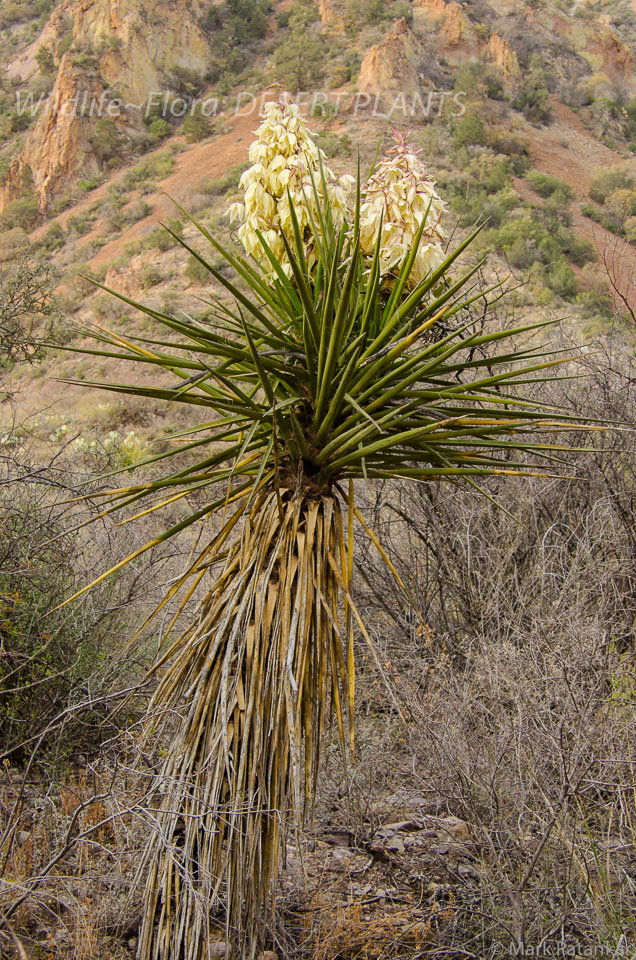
[138,491,349,960]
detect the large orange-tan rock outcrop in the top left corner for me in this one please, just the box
[0,0,210,210]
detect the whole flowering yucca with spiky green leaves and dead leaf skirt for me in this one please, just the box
[58,104,592,960]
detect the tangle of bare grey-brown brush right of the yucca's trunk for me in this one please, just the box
[326,334,636,957]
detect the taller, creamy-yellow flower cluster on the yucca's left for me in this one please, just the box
[228,94,355,276]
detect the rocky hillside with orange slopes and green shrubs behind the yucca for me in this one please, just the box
[0,0,636,436]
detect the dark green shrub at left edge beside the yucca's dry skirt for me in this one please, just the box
[0,466,152,765]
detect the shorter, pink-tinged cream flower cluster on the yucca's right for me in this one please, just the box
[360,133,446,284]
